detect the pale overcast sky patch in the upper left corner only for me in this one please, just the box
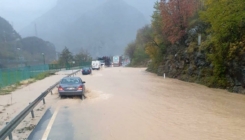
[0,0,57,31]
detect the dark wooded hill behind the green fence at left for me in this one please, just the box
[0,17,56,68]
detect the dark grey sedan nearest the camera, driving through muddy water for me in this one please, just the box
[58,77,85,99]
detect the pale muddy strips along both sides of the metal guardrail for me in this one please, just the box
[0,70,74,140]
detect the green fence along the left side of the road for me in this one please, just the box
[0,65,49,88]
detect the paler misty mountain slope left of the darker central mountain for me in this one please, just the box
[20,0,105,47]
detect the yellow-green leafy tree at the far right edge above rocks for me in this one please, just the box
[201,0,245,87]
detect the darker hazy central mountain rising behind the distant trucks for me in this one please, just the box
[65,0,147,56]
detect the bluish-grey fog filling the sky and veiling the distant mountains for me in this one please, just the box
[0,0,156,56]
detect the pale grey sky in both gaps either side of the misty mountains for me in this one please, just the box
[0,0,157,32]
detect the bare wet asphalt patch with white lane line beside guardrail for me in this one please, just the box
[28,98,76,140]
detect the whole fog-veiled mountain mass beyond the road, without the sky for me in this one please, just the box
[21,0,148,55]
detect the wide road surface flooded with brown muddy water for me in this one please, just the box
[31,68,245,140]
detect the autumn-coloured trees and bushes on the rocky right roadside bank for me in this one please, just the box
[125,0,245,93]
